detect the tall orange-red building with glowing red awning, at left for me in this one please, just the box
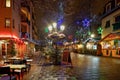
[0,0,36,56]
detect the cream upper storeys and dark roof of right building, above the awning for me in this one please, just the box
[102,0,120,38]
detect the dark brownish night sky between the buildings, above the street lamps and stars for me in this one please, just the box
[33,0,108,39]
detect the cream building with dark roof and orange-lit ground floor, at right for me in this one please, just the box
[101,0,120,57]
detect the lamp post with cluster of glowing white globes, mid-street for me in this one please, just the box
[48,23,65,65]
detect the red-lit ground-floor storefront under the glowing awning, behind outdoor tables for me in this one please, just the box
[0,37,26,58]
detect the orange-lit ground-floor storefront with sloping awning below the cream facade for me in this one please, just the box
[99,32,120,58]
